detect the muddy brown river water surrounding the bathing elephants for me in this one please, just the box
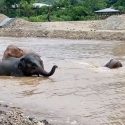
[0,37,125,125]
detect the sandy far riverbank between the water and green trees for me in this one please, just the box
[0,15,125,40]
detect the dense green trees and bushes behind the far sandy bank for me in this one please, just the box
[0,0,125,22]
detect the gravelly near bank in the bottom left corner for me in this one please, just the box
[0,103,50,125]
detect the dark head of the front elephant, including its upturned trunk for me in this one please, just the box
[18,53,57,77]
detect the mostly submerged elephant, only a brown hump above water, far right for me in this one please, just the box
[105,59,122,69]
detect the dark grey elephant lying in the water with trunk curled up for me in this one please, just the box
[0,53,57,77]
